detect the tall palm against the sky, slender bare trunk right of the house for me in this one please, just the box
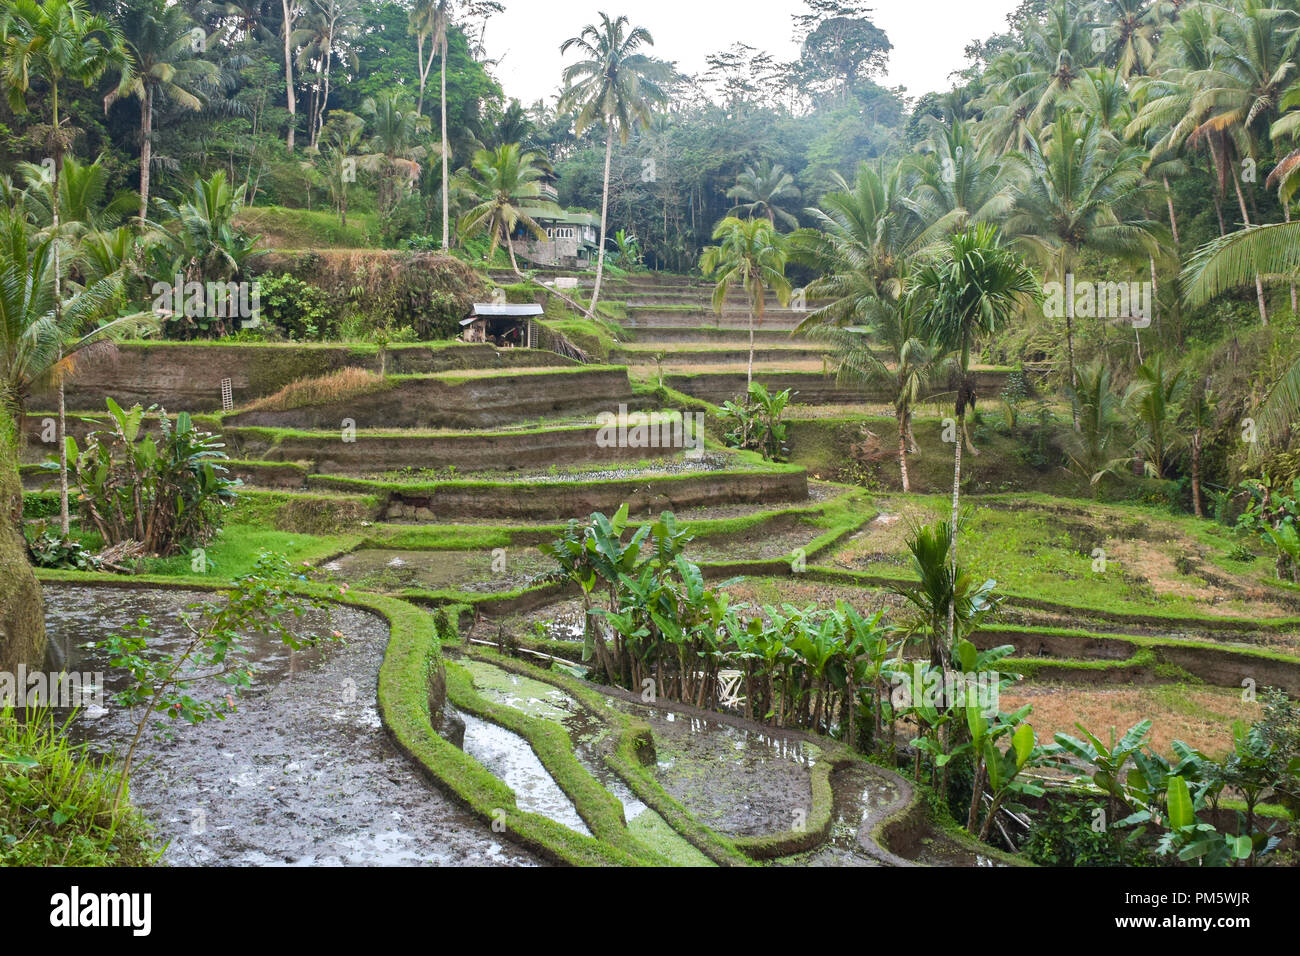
[559,13,668,312]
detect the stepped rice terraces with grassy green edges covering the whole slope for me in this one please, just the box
[23,280,1300,866]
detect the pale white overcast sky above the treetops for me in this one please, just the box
[485,0,1017,104]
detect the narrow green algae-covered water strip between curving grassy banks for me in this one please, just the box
[459,659,711,866]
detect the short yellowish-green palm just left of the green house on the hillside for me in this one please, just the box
[458,143,546,274]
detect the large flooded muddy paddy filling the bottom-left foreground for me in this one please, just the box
[46,585,538,866]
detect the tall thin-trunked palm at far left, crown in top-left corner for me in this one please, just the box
[0,0,131,537]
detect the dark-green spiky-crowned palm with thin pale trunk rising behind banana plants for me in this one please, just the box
[915,222,1039,658]
